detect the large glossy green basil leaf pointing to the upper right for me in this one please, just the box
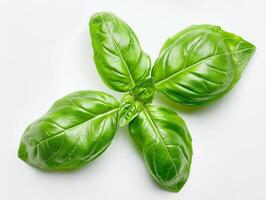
[152,25,255,105]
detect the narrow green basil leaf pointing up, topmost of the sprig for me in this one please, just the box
[89,12,151,92]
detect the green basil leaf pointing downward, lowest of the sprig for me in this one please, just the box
[129,105,193,192]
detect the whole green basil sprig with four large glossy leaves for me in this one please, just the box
[18,12,255,192]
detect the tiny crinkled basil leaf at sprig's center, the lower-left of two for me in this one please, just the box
[118,94,143,126]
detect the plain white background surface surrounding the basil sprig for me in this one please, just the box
[0,0,266,200]
